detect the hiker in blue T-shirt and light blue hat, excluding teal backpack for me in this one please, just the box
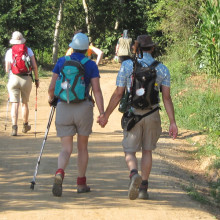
[48,33,104,196]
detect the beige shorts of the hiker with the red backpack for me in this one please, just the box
[7,73,32,104]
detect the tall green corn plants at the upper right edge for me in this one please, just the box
[194,0,220,78]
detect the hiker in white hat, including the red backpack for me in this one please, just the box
[5,31,39,136]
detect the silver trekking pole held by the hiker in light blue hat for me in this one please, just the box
[30,106,55,190]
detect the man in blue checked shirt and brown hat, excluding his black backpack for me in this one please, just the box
[98,35,178,200]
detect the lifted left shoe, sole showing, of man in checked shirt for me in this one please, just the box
[128,173,142,200]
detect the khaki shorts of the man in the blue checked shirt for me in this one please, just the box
[122,110,162,153]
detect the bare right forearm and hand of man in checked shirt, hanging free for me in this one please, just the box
[162,86,178,139]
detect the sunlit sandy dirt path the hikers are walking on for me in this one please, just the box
[0,62,218,220]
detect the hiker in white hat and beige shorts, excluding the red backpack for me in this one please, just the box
[5,31,39,136]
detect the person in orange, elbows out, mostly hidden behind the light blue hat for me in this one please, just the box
[66,43,104,66]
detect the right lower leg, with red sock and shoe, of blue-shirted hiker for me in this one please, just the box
[77,135,90,193]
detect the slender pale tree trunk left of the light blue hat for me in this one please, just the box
[53,0,64,64]
